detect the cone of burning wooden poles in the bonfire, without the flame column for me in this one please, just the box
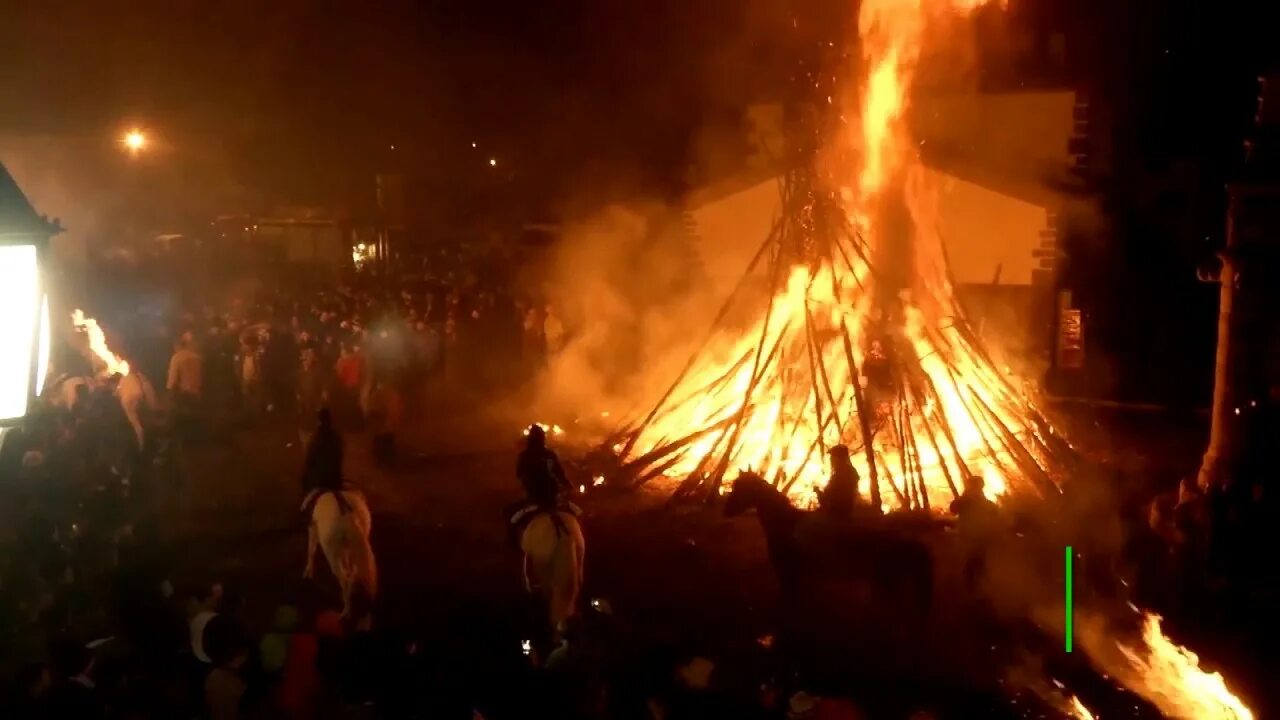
[604,163,1071,510]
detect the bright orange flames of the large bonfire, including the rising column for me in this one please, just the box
[614,0,1052,507]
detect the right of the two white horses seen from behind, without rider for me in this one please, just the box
[520,511,586,633]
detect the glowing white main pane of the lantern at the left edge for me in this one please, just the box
[0,245,40,420]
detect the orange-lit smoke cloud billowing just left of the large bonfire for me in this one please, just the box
[536,202,718,416]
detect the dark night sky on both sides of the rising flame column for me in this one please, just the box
[0,0,1268,219]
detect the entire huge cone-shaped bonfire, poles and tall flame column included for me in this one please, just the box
[620,0,1071,509]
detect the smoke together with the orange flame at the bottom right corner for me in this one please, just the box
[967,456,1253,720]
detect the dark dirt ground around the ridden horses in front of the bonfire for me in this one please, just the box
[142,404,1249,717]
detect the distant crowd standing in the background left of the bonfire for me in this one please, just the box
[153,272,564,448]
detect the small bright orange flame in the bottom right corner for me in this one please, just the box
[1116,612,1253,720]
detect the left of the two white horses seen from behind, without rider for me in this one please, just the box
[302,489,378,621]
